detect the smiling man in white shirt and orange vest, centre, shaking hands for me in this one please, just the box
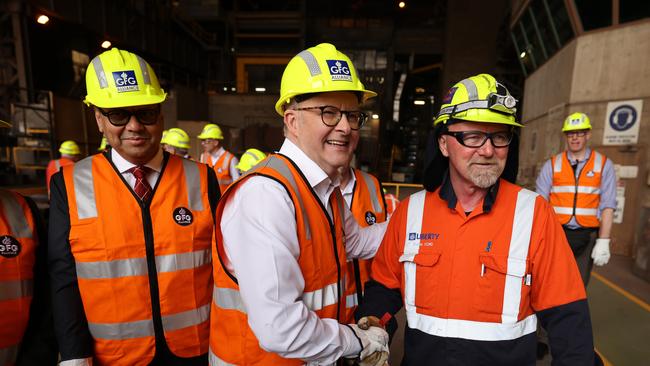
[210,43,388,366]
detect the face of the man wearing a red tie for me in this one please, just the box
[95,105,163,164]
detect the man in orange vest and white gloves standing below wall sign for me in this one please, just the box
[536,113,616,287]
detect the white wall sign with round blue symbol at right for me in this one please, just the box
[603,99,643,145]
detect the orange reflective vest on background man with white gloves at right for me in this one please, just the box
[549,150,607,228]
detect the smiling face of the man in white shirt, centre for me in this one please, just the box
[284,92,359,178]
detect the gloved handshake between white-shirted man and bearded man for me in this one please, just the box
[348,316,389,366]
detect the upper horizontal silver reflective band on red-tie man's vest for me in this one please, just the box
[75,249,212,280]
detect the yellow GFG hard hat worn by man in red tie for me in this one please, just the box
[84,48,167,108]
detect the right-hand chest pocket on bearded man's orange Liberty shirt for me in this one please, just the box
[474,254,530,317]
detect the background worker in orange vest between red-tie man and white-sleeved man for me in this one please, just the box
[197,123,240,193]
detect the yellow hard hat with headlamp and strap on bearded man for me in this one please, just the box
[433,74,522,127]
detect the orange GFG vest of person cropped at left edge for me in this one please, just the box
[0,189,37,366]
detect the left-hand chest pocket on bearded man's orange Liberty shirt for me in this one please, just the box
[399,253,441,309]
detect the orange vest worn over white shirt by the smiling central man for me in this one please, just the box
[209,154,346,366]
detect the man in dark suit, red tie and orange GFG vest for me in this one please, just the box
[49,48,219,366]
